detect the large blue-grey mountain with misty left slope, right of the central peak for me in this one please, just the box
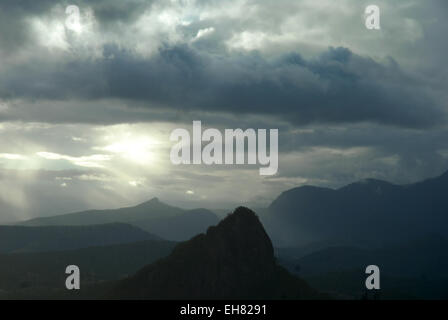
[265,173,448,245]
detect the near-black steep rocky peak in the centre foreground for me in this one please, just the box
[110,207,317,299]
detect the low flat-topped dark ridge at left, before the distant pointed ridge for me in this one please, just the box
[0,223,160,253]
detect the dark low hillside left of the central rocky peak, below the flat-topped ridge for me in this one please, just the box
[0,240,176,299]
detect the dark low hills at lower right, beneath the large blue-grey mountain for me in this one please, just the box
[279,235,448,299]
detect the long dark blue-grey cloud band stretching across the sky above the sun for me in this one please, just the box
[0,45,445,127]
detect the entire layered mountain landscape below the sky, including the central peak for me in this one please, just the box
[0,169,448,299]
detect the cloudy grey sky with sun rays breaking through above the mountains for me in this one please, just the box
[0,0,448,223]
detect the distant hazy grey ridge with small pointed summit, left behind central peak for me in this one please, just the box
[21,198,219,241]
